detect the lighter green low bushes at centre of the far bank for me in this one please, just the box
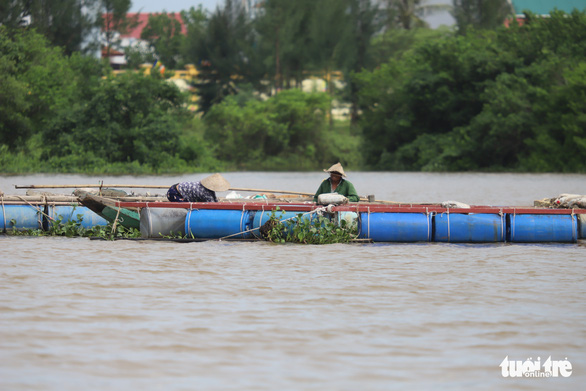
[204,90,329,169]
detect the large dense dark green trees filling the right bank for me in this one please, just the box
[357,11,586,172]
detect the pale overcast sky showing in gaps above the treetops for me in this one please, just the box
[130,0,454,28]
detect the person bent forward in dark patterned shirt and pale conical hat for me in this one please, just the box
[167,173,230,202]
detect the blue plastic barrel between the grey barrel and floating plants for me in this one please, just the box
[185,209,252,239]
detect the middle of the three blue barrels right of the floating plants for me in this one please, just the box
[434,213,506,243]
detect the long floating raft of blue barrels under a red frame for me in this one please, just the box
[0,201,586,243]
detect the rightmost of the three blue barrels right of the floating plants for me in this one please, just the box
[508,215,578,242]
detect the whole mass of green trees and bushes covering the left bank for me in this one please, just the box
[0,26,212,174]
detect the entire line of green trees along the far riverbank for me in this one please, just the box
[0,0,586,173]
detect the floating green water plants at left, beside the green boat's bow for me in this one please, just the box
[6,214,140,240]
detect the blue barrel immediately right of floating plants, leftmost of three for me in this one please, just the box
[358,213,432,242]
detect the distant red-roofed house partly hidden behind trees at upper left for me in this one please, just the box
[102,13,187,69]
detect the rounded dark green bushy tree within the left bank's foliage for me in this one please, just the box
[45,72,187,168]
